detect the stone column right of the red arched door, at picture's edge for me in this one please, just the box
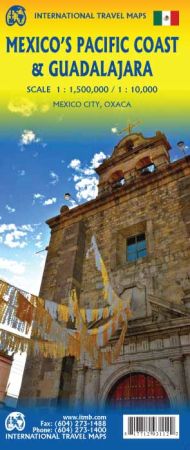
[171,356,188,404]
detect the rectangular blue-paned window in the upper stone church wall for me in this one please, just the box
[127,233,147,261]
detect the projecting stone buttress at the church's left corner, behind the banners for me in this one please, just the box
[20,218,85,402]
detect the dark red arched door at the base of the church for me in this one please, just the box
[107,372,170,407]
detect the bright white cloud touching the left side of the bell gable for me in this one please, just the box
[68,151,106,202]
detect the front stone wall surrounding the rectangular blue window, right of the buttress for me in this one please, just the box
[80,169,190,307]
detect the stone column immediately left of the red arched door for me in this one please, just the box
[84,368,100,405]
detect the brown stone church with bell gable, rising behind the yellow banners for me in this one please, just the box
[20,132,190,406]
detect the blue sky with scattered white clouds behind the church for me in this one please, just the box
[0,114,190,293]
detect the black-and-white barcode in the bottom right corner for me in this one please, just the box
[123,414,179,439]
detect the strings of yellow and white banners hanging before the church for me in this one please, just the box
[0,272,129,365]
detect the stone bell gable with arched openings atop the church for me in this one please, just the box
[96,131,171,195]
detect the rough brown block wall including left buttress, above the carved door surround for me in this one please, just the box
[21,162,190,399]
